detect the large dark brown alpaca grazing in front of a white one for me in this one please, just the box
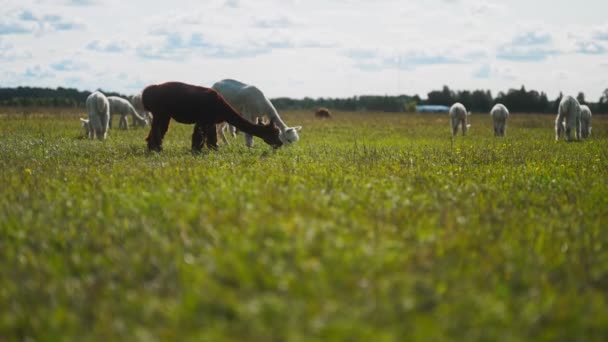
[142,82,283,151]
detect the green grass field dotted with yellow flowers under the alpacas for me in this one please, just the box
[0,112,608,341]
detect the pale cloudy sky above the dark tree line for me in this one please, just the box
[0,0,608,101]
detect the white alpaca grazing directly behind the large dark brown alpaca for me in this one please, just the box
[212,79,302,147]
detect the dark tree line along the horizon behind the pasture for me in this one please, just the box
[0,86,608,114]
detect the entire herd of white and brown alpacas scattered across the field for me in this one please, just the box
[80,84,592,147]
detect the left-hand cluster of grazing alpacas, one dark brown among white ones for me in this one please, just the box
[80,80,302,151]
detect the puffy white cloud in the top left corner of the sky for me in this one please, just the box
[0,10,84,35]
